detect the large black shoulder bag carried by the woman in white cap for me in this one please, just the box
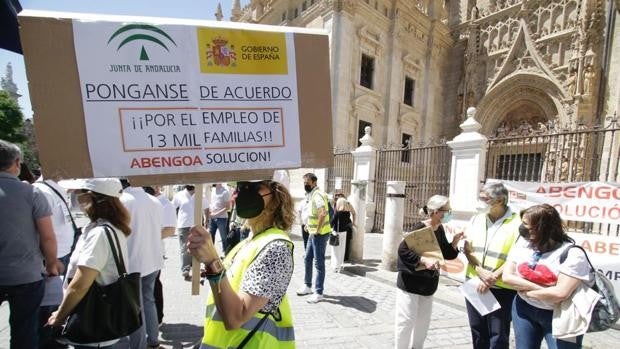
[62,225,142,343]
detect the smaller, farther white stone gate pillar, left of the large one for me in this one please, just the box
[351,126,377,233]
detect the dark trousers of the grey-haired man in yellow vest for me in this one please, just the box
[466,288,517,349]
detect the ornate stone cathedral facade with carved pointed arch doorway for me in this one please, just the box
[230,0,620,147]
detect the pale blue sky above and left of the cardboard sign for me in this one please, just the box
[0,0,249,118]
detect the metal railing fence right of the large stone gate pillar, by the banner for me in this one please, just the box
[486,118,620,236]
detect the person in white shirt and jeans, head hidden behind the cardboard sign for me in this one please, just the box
[120,180,163,348]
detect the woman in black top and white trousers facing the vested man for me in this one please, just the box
[395,195,463,349]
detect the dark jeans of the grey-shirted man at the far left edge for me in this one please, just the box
[0,280,45,349]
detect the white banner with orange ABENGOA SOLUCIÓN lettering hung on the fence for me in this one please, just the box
[498,180,620,224]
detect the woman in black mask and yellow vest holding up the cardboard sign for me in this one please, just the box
[188,181,295,348]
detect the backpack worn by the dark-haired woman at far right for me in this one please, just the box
[560,245,620,332]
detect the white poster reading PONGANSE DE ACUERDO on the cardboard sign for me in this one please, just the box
[73,20,301,177]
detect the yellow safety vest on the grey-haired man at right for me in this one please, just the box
[465,212,521,290]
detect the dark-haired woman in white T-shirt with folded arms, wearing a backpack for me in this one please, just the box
[503,204,593,349]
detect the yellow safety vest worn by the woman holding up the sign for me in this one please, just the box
[200,228,295,349]
